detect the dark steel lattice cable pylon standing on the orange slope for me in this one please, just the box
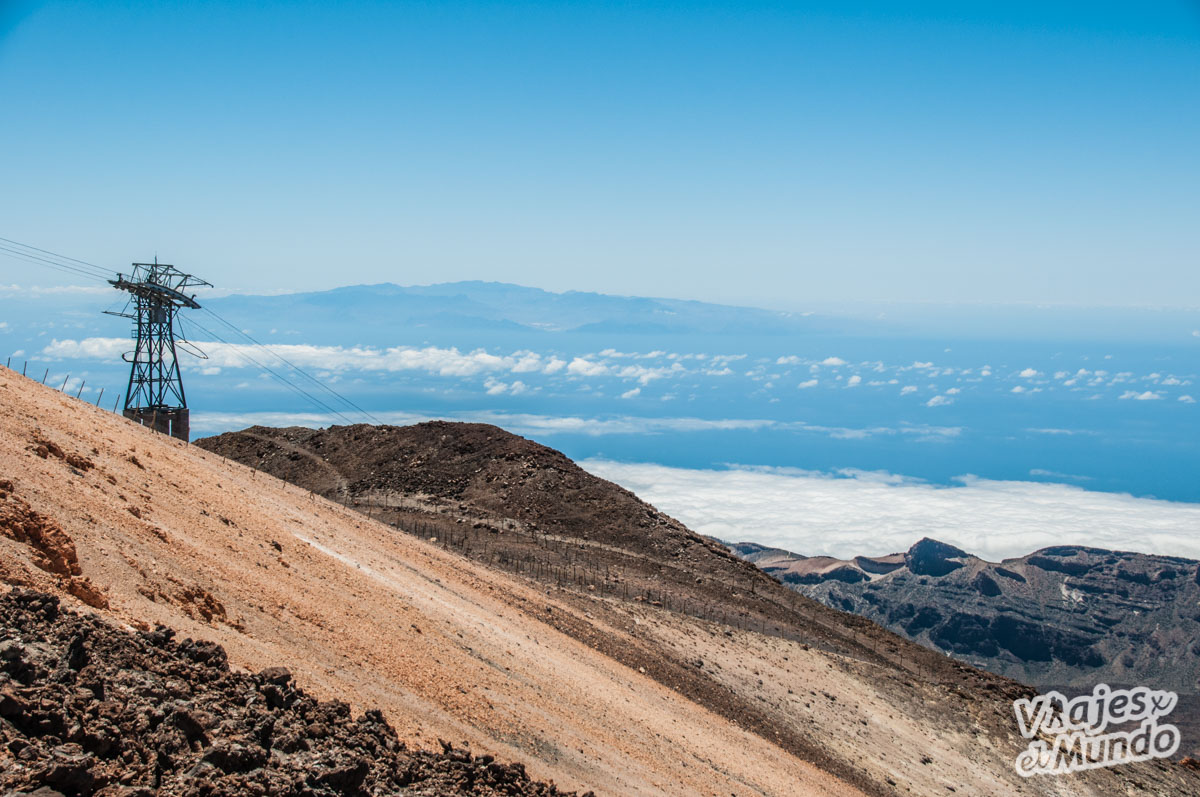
[108,258,211,441]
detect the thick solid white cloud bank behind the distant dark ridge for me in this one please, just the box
[582,460,1200,561]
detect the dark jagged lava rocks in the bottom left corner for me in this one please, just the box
[0,589,590,797]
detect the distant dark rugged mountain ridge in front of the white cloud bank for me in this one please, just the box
[731,539,1200,693]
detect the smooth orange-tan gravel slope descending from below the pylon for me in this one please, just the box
[0,371,858,795]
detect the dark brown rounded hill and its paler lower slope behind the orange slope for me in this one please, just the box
[197,423,1198,795]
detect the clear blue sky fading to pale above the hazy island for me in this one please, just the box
[0,0,1200,307]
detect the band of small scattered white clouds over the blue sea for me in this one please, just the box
[37,330,1200,414]
